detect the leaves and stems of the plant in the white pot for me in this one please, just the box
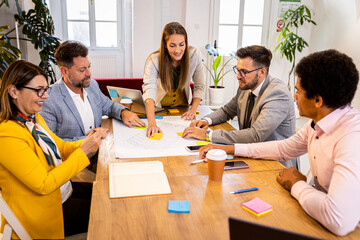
[204,44,234,88]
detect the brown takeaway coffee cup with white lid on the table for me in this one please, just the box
[206,149,227,181]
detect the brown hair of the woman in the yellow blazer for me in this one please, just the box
[0,60,47,123]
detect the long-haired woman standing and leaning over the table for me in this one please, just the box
[143,22,205,137]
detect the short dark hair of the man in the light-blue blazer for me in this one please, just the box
[55,41,88,69]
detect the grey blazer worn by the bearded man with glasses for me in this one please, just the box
[206,75,296,167]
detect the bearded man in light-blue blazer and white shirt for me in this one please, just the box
[40,41,145,141]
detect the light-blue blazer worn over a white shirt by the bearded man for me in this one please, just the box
[40,78,125,141]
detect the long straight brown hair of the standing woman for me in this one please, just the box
[155,22,189,91]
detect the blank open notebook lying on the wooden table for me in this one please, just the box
[109,161,171,198]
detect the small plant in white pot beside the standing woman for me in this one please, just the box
[204,44,235,105]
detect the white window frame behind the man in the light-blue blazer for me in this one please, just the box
[61,0,125,52]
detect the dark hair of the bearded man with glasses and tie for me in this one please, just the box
[236,45,272,72]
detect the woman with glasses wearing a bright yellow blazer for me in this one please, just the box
[0,60,107,239]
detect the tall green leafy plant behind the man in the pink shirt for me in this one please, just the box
[274,5,316,90]
